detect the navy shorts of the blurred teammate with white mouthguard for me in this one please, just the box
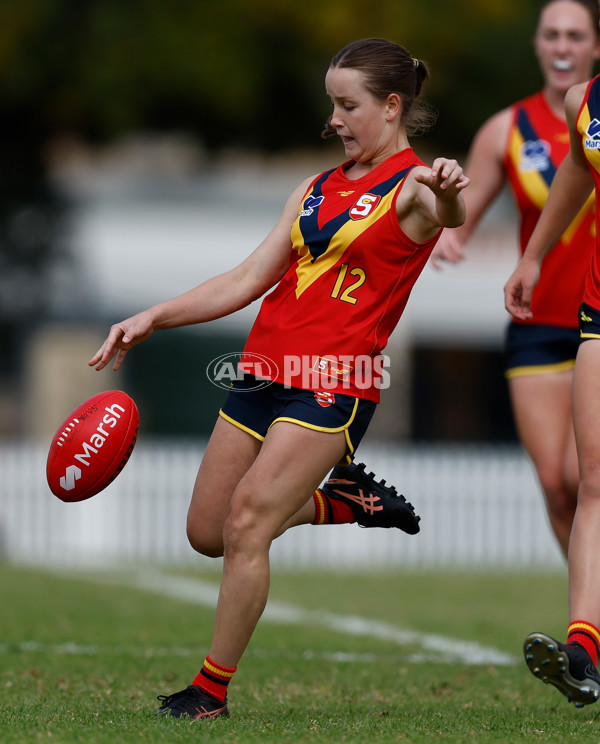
[504,323,580,379]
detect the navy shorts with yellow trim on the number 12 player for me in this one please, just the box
[219,375,377,464]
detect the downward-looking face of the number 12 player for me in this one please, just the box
[325,67,397,163]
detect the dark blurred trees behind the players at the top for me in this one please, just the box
[0,0,552,438]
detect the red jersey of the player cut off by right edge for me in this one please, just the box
[576,75,600,310]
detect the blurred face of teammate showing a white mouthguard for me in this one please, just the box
[535,0,600,94]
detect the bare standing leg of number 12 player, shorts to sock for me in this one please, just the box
[209,422,346,667]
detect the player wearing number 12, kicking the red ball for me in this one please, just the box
[90,39,468,718]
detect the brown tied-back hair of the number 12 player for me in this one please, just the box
[321,38,436,137]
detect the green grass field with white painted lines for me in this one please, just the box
[0,565,600,744]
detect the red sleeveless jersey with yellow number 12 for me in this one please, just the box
[241,149,439,402]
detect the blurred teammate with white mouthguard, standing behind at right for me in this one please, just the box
[433,0,600,556]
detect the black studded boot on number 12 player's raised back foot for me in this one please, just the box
[321,463,421,535]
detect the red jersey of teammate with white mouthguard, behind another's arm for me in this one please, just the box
[505,92,595,328]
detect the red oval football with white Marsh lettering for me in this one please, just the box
[46,390,140,501]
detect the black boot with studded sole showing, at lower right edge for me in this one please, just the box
[523,633,600,708]
